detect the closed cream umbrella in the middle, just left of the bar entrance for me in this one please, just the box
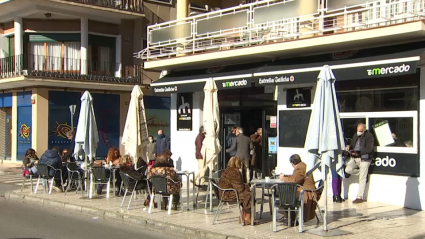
[201,79,221,172]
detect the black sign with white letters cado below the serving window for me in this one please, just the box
[369,152,419,177]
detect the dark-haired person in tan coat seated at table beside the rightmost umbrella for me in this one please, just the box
[280,154,316,225]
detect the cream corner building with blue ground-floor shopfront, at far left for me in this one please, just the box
[0,0,179,162]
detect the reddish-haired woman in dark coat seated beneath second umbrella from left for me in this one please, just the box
[120,154,151,206]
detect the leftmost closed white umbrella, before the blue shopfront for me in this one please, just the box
[74,91,99,166]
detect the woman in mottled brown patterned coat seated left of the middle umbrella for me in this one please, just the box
[148,154,182,210]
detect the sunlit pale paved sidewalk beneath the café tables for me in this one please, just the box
[6,187,425,239]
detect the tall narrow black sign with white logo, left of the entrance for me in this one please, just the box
[176,93,193,131]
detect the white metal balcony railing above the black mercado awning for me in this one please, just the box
[135,0,425,60]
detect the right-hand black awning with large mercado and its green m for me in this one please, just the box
[254,46,425,86]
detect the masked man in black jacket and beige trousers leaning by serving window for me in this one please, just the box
[345,123,375,203]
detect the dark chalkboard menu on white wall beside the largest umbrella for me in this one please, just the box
[279,110,311,148]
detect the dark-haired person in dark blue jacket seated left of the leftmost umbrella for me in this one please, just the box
[38,146,67,191]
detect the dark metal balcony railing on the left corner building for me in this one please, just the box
[0,55,143,84]
